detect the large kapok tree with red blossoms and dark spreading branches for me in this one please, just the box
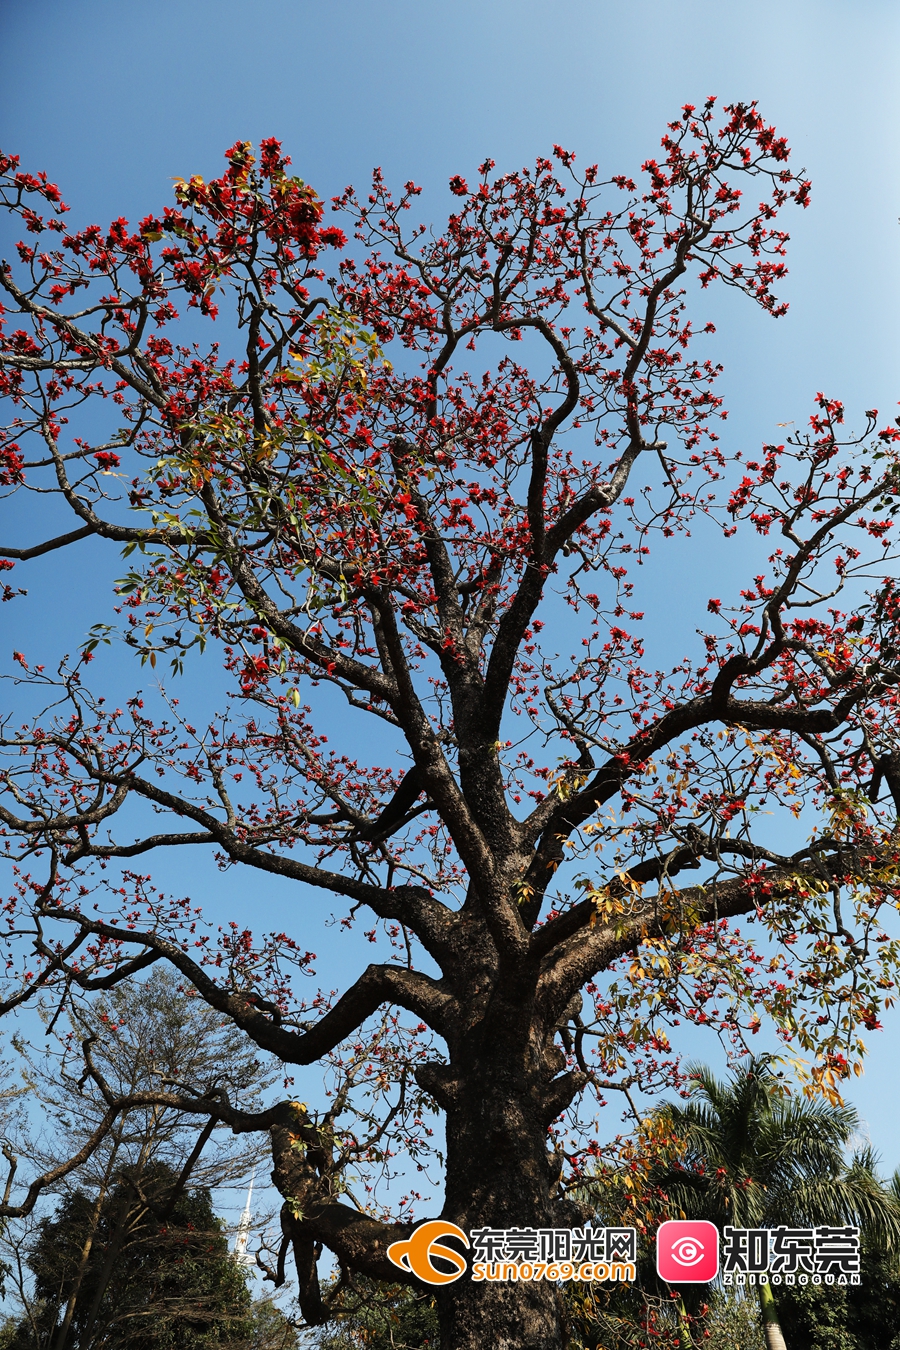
[0,101,900,1350]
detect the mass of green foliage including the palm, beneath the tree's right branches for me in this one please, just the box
[567,1056,900,1350]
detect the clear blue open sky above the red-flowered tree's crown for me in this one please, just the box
[0,0,900,1168]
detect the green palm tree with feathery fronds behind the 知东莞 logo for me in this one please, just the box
[652,1054,900,1350]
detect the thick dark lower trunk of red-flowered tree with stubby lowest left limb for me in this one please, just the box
[282,953,590,1350]
